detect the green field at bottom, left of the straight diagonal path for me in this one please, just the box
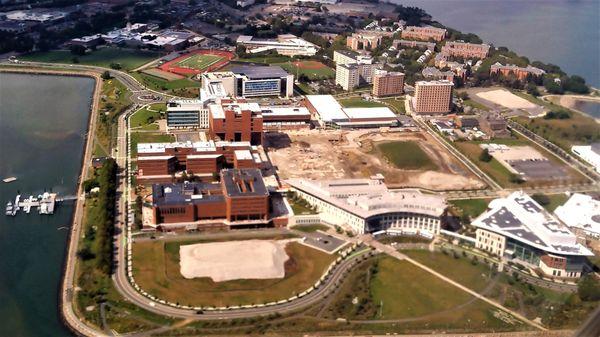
[327,256,522,333]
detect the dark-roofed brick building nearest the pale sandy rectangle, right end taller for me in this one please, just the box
[152,169,270,230]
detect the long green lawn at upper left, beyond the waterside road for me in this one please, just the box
[19,47,162,70]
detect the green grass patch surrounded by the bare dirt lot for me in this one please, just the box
[375,141,437,170]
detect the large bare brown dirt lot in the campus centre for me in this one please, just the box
[265,130,484,190]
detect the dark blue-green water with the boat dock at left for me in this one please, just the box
[0,73,94,337]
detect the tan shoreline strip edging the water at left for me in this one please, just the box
[0,66,103,336]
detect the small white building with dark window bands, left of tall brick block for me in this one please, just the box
[167,99,209,129]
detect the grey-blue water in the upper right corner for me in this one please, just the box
[390,0,600,88]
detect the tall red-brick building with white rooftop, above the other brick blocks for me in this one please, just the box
[208,99,263,145]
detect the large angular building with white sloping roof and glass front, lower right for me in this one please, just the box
[472,192,594,278]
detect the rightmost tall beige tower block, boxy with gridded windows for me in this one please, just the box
[413,80,454,115]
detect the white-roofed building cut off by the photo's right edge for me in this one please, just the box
[554,193,600,240]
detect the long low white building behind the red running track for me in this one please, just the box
[236,34,320,56]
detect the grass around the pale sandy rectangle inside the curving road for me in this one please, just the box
[133,236,336,306]
